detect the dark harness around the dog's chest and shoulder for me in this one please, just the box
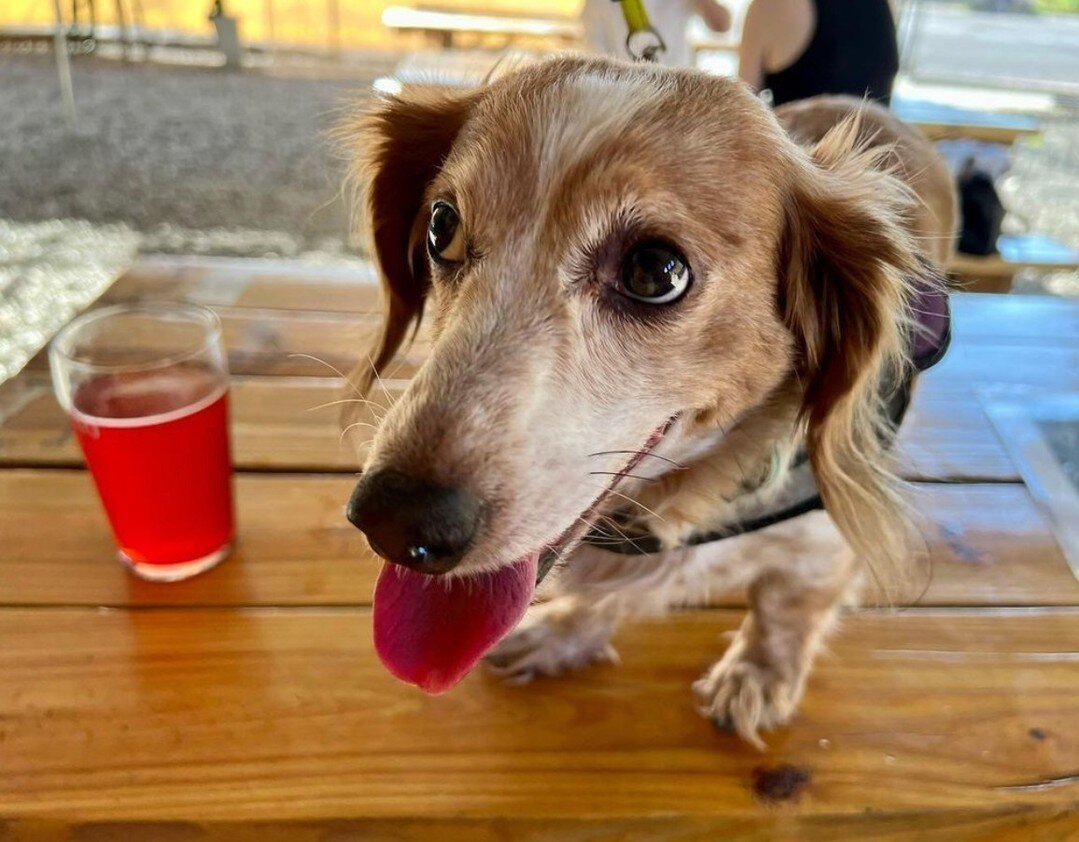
[574,282,952,560]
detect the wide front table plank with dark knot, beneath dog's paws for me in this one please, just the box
[0,609,1079,838]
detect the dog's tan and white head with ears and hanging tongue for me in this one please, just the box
[349,59,927,691]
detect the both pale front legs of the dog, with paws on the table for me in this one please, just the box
[488,512,850,725]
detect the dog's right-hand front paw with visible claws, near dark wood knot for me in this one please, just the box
[693,632,803,750]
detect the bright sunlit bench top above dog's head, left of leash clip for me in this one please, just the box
[382,5,584,49]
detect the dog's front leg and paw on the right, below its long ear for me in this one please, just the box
[693,535,856,748]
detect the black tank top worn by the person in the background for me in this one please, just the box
[764,0,899,106]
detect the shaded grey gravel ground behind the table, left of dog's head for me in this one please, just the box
[0,52,390,256]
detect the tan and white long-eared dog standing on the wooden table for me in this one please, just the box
[338,57,956,746]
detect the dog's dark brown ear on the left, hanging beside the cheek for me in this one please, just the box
[343,87,477,392]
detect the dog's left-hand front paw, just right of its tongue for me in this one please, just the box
[487,597,618,684]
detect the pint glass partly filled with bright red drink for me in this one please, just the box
[51,304,235,581]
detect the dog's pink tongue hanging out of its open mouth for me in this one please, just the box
[374,553,540,693]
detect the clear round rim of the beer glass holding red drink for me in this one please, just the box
[49,301,221,374]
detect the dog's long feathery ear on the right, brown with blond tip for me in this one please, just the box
[777,120,931,591]
